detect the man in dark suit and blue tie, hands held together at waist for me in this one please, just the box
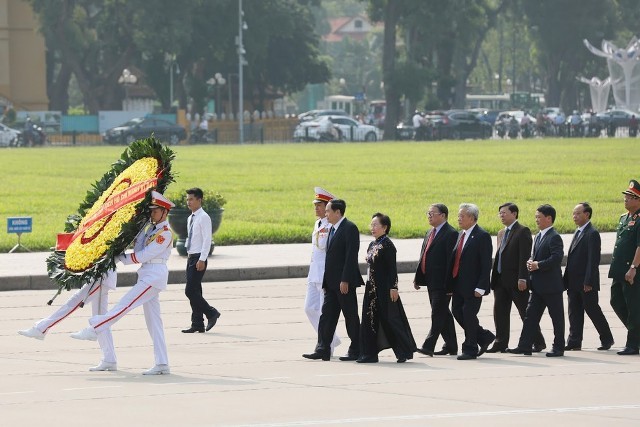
[509,205,564,357]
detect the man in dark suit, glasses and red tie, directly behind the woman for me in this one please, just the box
[413,203,458,356]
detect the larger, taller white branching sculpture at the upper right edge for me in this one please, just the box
[584,36,640,111]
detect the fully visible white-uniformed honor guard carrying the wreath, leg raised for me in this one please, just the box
[74,191,175,375]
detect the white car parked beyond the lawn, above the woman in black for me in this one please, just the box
[293,116,382,141]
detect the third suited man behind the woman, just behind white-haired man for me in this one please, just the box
[487,203,546,353]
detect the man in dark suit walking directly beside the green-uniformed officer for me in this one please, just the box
[563,202,613,350]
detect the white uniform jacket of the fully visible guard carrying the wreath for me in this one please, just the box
[119,221,173,290]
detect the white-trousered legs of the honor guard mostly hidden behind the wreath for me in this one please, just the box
[18,270,118,371]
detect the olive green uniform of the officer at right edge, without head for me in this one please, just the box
[609,210,640,350]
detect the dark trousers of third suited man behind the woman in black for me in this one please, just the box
[493,280,546,349]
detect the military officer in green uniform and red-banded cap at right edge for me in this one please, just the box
[609,180,640,355]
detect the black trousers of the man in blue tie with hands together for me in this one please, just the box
[518,291,564,351]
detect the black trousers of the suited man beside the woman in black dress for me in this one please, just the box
[315,287,360,357]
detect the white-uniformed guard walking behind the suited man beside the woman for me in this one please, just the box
[304,187,340,353]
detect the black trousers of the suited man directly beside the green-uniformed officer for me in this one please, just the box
[567,289,613,346]
